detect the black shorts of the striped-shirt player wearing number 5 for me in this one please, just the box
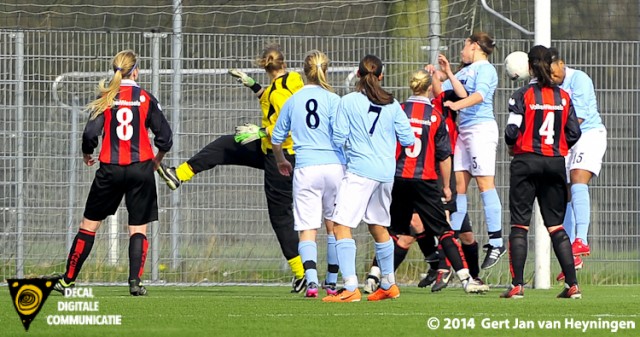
[390,178,451,236]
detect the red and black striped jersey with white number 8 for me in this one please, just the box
[82,79,173,165]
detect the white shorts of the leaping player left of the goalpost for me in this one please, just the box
[453,121,498,177]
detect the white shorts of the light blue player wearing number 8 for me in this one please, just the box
[293,164,345,231]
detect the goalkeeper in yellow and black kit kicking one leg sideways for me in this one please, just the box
[158,45,307,293]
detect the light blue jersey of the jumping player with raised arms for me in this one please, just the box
[442,60,498,127]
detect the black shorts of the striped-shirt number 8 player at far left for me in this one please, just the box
[84,160,158,225]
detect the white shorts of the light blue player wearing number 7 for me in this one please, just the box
[330,172,393,228]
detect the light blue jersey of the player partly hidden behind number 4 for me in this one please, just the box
[560,67,604,132]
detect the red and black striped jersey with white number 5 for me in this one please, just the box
[395,96,451,180]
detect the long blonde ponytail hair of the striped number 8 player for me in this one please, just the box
[87,50,138,119]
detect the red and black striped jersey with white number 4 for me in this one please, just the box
[505,81,581,157]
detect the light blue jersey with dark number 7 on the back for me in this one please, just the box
[333,92,415,182]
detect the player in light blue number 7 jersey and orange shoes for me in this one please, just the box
[322,55,415,302]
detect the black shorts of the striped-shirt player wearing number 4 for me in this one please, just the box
[509,153,568,227]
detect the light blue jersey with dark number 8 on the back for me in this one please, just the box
[271,84,346,168]
